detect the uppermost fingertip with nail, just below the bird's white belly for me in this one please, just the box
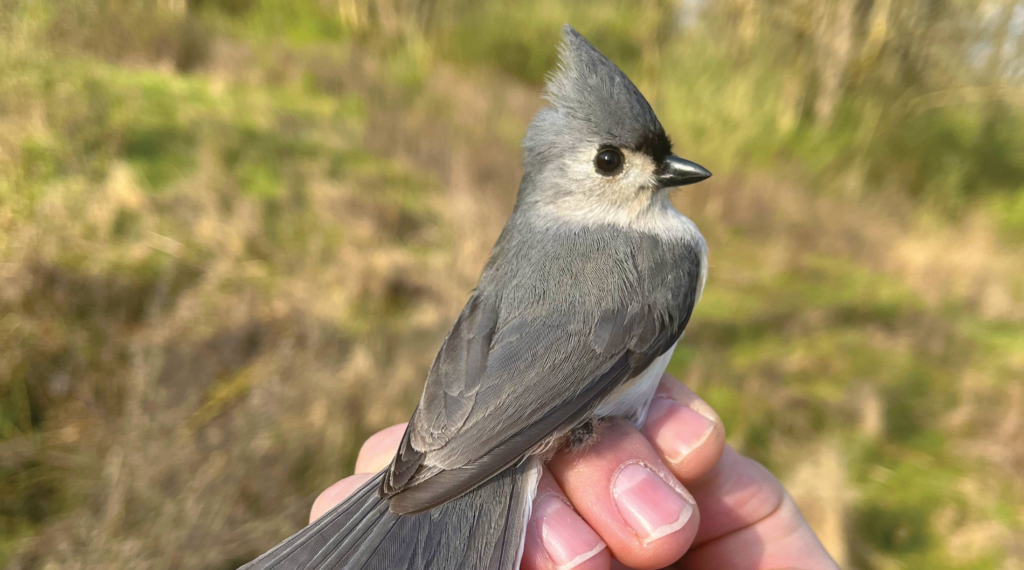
[643,375,725,485]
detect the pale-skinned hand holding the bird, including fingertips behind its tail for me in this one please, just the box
[309,376,839,570]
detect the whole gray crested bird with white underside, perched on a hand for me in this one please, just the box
[243,26,711,570]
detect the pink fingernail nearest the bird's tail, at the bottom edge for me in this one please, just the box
[534,496,605,570]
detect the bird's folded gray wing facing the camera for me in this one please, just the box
[381,279,696,513]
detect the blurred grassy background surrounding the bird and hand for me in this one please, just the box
[0,0,1024,570]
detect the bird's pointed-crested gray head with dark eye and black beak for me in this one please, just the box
[520,25,711,221]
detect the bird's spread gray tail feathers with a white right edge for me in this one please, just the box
[240,459,541,570]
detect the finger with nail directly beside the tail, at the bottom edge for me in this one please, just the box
[520,470,611,570]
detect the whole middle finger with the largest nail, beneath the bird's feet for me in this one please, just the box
[549,420,698,570]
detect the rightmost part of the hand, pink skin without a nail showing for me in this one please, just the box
[683,447,838,570]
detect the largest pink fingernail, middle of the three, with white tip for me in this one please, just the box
[611,464,693,544]
